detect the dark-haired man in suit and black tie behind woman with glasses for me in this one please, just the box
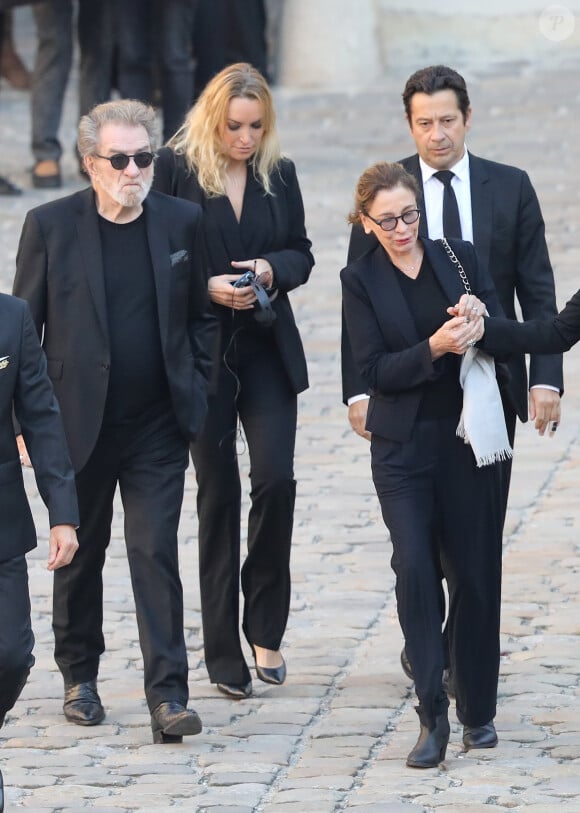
[342,65,563,692]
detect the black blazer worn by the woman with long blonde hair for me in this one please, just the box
[153,147,314,393]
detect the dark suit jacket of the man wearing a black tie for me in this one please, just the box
[342,153,564,421]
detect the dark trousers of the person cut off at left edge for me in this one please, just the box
[0,556,34,726]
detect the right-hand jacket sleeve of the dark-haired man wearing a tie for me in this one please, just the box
[516,172,563,390]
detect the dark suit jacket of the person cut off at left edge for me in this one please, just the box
[0,294,79,561]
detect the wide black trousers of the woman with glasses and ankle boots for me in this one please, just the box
[371,417,503,727]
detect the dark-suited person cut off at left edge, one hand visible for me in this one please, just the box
[0,294,79,810]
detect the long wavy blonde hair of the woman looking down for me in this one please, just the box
[167,62,282,197]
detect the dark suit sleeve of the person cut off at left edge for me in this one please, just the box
[14,306,79,527]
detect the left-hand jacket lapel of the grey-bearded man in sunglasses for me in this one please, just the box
[76,187,109,345]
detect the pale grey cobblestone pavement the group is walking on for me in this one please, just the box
[0,7,580,813]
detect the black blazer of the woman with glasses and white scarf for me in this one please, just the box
[340,238,502,442]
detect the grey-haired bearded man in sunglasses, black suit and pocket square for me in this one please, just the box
[14,100,217,742]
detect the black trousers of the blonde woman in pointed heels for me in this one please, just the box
[191,333,297,684]
